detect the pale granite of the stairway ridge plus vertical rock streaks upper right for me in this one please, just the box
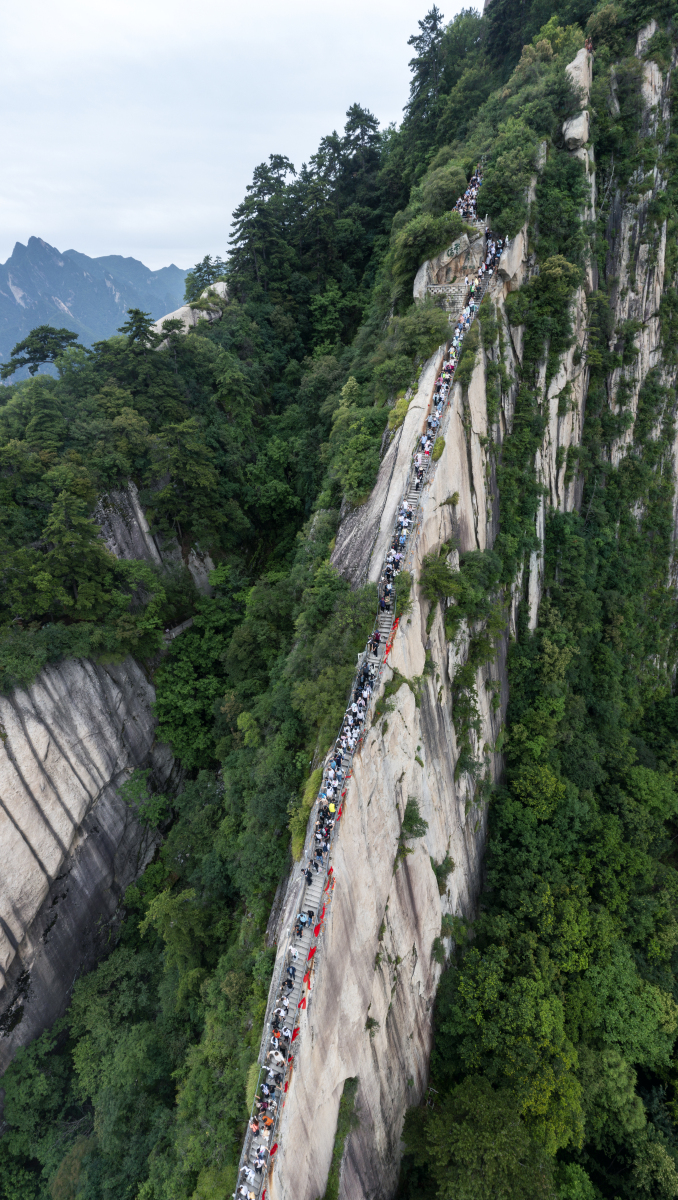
[271,32,678,1200]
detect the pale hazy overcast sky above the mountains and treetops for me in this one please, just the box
[0,0,468,268]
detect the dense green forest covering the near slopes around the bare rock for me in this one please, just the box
[0,0,678,1200]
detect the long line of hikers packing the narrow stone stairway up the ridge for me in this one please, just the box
[234,168,506,1200]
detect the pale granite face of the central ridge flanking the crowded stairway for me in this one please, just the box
[271,359,506,1200]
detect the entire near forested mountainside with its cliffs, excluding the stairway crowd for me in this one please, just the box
[0,0,678,1200]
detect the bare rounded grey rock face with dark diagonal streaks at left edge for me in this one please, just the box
[0,659,173,1073]
